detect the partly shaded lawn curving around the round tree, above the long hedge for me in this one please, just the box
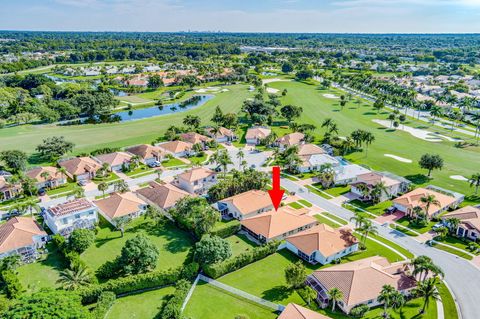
[81,217,193,270]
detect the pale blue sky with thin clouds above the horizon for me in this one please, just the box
[0,0,480,33]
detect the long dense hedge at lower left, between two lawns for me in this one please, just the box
[78,263,200,304]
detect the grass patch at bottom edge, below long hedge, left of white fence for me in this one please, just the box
[106,287,175,319]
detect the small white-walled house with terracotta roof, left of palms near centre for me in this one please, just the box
[174,167,217,194]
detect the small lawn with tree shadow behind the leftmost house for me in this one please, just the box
[17,243,67,292]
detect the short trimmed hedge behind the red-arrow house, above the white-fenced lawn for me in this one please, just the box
[203,241,280,278]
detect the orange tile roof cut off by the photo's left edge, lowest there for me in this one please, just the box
[0,217,47,253]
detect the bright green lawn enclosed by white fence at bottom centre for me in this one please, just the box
[184,282,277,319]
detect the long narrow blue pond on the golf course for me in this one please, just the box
[114,95,213,122]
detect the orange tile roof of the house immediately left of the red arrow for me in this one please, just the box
[220,190,273,215]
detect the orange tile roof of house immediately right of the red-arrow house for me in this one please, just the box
[287,224,358,257]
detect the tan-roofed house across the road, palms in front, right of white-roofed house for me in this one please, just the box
[350,172,411,202]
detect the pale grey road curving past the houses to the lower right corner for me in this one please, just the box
[282,178,480,319]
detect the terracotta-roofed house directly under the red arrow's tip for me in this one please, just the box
[240,206,318,243]
